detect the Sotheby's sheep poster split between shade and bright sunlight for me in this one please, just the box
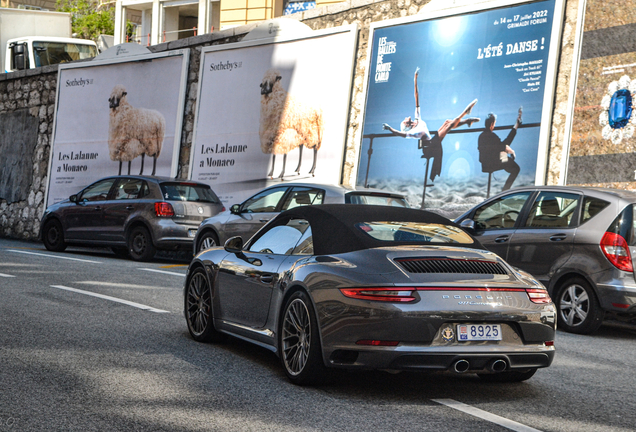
[190,26,357,206]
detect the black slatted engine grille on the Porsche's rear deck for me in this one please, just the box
[395,258,508,275]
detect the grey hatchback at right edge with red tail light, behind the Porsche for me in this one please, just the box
[455,186,636,334]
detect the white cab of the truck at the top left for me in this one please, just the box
[4,36,99,72]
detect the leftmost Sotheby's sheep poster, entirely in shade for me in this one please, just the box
[47,50,189,206]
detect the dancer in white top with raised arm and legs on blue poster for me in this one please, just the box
[382,67,480,180]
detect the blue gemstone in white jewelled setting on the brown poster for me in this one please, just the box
[599,75,636,144]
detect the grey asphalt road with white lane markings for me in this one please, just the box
[0,239,636,432]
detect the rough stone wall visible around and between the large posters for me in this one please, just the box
[0,0,579,240]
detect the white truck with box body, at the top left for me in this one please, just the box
[0,8,98,72]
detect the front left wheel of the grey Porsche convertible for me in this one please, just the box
[184,268,224,342]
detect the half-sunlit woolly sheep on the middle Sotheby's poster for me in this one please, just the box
[259,69,324,180]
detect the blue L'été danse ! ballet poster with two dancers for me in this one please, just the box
[356,0,563,216]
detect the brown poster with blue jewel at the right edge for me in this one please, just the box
[566,0,636,189]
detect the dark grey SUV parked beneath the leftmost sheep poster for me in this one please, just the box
[40,175,224,261]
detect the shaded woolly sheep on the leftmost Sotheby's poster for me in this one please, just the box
[108,85,166,175]
